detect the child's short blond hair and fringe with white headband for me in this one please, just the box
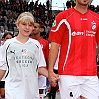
[16,12,35,24]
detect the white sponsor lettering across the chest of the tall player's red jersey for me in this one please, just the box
[71,30,96,37]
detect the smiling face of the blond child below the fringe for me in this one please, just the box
[17,22,34,36]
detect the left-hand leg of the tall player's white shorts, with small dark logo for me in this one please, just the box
[59,75,81,99]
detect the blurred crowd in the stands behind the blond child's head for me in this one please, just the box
[0,0,54,39]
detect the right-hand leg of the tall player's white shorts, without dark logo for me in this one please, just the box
[81,76,99,99]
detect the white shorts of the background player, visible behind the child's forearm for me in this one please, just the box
[38,75,46,89]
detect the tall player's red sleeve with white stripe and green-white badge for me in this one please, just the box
[48,12,66,44]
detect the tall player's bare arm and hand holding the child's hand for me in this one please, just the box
[48,42,60,86]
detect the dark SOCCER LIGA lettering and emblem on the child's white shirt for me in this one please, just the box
[11,49,38,67]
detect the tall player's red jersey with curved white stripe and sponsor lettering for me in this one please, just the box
[49,8,99,76]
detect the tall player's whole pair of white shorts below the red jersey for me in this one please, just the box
[59,75,99,99]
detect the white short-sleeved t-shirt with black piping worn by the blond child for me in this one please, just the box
[0,37,46,99]
